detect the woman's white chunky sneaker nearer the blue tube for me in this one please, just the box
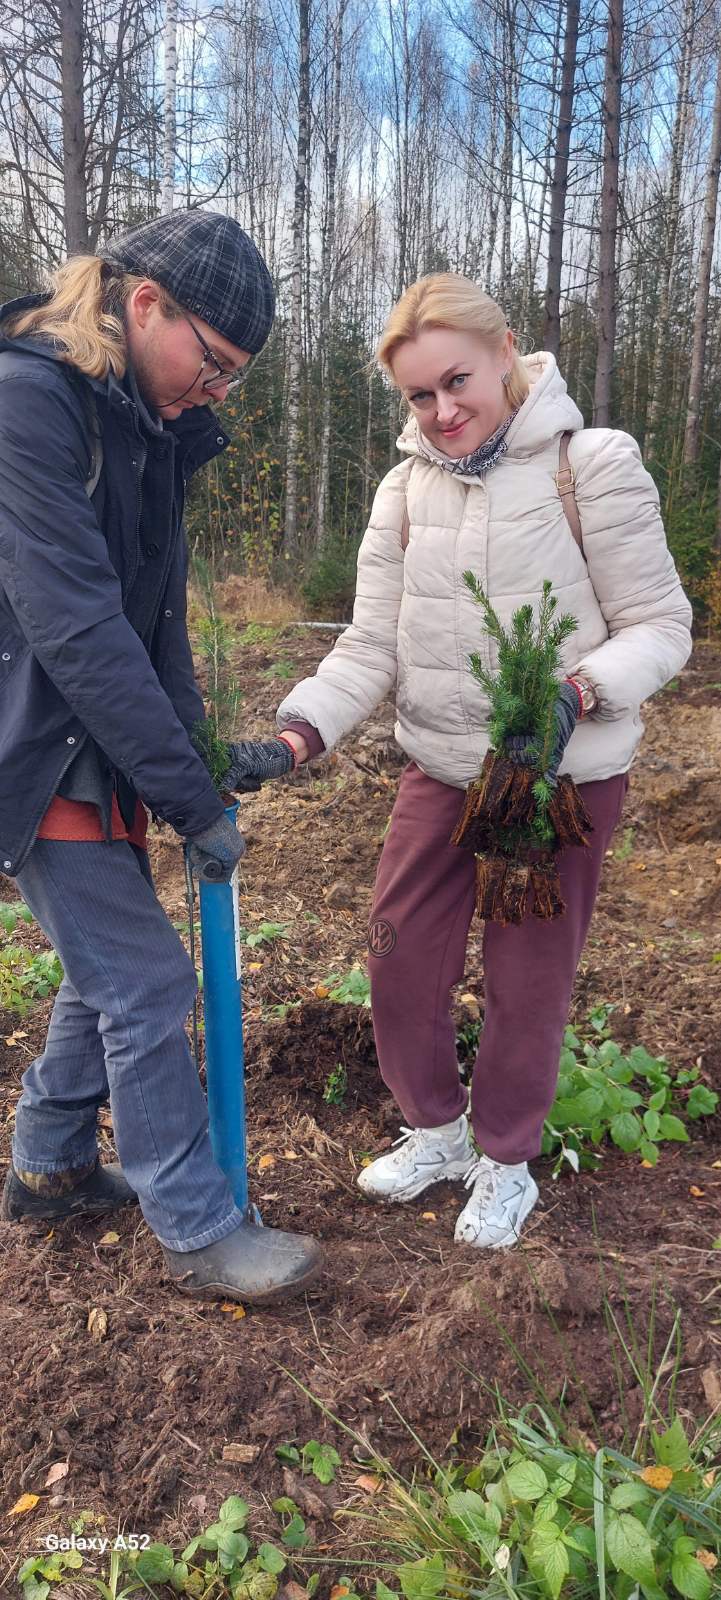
[358,1115,475,1200]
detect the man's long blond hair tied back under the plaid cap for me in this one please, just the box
[3,256,181,378]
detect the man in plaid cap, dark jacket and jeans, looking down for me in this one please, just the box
[0,211,320,1302]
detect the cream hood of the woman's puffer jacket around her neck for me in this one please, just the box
[396,350,584,483]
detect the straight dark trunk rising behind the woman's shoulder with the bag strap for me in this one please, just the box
[593,0,623,427]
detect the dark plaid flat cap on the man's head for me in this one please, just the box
[96,211,275,355]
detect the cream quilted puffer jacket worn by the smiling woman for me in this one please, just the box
[278,354,692,789]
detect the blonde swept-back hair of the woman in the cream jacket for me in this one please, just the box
[376,272,531,410]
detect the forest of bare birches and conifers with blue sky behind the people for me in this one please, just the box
[0,0,721,621]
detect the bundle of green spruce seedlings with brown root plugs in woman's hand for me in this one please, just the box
[451,573,592,923]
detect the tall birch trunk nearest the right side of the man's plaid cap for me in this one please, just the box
[285,0,310,554]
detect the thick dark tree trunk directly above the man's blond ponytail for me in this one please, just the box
[59,0,90,256]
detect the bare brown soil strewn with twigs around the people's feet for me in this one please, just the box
[0,611,721,1597]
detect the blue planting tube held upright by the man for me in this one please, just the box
[198,805,248,1211]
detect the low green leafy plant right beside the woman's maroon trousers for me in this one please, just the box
[542,1006,718,1176]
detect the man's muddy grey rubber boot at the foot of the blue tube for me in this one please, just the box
[160,1222,323,1306]
